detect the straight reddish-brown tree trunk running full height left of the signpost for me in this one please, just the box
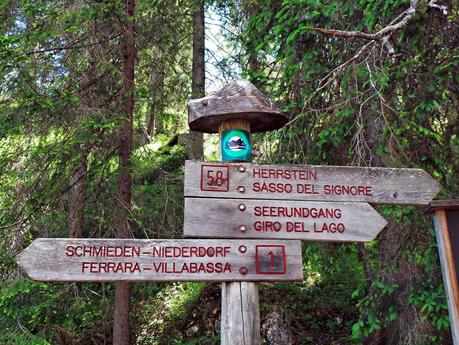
[113,0,135,345]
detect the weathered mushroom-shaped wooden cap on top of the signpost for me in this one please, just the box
[188,80,288,133]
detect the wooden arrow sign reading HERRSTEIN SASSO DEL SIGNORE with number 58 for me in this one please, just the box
[185,161,441,205]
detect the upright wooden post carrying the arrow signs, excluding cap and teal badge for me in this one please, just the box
[218,119,261,345]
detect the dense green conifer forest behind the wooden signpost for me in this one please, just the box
[0,0,459,345]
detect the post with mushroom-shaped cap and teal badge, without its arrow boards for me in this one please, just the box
[188,80,288,345]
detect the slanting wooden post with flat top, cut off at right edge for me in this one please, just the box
[427,200,459,345]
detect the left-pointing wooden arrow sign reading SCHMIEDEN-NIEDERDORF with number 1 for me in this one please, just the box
[16,238,303,281]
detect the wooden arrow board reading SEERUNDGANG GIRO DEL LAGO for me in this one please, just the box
[184,198,387,242]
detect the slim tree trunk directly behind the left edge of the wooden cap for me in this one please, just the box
[188,0,205,159]
